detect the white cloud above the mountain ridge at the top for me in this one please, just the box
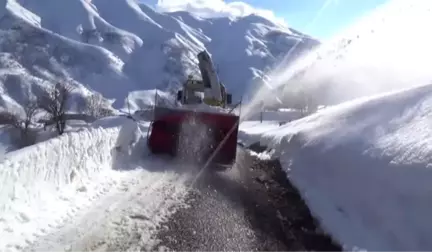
[156,0,286,26]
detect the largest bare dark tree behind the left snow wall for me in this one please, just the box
[37,82,73,135]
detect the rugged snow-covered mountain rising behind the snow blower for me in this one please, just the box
[0,0,319,111]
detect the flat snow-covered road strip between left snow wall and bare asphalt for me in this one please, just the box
[31,162,188,252]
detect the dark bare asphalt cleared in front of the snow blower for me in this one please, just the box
[154,148,342,252]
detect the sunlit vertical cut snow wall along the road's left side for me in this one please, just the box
[0,128,119,218]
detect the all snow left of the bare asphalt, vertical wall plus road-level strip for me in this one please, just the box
[0,117,187,252]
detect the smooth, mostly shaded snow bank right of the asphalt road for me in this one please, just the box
[240,86,432,252]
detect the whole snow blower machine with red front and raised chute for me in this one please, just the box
[148,51,239,170]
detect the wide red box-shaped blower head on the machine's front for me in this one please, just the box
[147,107,239,169]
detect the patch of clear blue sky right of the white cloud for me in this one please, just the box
[227,0,388,39]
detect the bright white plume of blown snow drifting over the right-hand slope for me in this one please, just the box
[241,0,432,117]
